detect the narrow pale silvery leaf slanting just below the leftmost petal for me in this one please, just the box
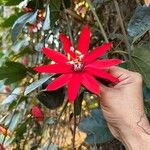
[24,76,51,95]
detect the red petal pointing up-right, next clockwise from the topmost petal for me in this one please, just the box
[83,43,112,63]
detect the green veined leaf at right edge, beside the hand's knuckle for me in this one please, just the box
[132,46,150,88]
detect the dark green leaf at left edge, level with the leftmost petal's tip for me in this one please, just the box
[0,61,27,85]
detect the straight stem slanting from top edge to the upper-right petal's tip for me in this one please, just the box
[86,0,109,43]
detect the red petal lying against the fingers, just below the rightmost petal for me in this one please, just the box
[86,68,119,82]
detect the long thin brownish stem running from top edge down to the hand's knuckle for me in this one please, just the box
[113,0,132,69]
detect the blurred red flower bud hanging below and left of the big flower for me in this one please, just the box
[32,106,44,121]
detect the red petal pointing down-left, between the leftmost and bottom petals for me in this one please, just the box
[47,74,72,91]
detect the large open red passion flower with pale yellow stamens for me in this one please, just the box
[34,25,122,103]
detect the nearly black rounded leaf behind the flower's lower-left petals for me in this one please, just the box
[37,88,65,109]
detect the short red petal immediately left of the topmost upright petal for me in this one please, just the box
[59,33,75,58]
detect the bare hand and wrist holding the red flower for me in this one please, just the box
[101,67,150,150]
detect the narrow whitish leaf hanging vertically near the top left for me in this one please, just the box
[43,5,51,30]
